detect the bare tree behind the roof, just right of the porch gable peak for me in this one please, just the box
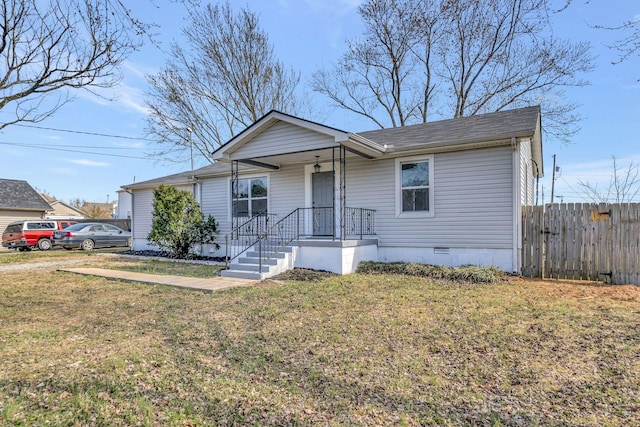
[312,0,440,128]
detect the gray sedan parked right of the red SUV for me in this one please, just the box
[52,222,131,251]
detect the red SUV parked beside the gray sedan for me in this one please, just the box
[2,219,77,251]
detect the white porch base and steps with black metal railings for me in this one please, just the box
[221,208,378,280]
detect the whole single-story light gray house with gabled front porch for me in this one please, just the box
[123,107,543,277]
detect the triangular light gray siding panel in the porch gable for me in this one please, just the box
[230,122,336,160]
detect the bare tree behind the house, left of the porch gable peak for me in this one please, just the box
[147,3,300,165]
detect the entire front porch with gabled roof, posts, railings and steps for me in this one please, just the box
[214,112,386,275]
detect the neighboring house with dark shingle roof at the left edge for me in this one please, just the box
[0,179,51,250]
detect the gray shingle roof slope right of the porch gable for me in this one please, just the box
[358,106,540,151]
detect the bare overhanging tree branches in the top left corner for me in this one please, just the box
[0,0,150,129]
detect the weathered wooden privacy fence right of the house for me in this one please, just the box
[522,203,640,285]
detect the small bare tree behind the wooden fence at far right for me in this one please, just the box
[578,156,640,203]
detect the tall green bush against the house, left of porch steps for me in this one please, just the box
[147,185,219,258]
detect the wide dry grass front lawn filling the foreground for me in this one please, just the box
[0,252,640,426]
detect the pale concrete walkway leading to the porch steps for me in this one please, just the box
[58,268,260,293]
